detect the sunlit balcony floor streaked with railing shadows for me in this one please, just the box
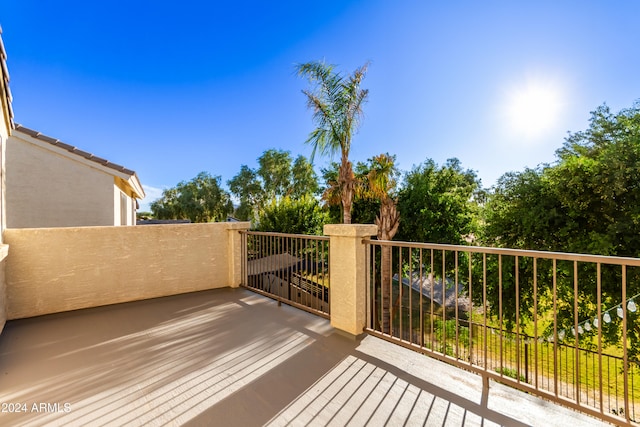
[0,289,602,426]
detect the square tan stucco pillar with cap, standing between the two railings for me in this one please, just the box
[324,224,378,337]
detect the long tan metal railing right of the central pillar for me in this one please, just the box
[365,239,640,424]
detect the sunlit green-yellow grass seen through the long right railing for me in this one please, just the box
[376,283,640,416]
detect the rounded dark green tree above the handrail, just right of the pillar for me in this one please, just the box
[398,159,480,244]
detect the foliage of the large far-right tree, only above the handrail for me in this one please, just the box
[483,104,640,257]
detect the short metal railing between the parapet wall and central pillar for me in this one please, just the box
[242,231,330,318]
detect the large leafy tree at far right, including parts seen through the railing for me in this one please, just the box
[483,103,640,355]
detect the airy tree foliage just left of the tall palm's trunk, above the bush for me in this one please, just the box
[227,149,319,221]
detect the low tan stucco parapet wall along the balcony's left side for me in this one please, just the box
[4,223,249,319]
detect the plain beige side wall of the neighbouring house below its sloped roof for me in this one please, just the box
[5,136,119,228]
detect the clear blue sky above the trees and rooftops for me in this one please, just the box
[0,0,640,209]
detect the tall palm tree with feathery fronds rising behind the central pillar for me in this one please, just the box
[296,61,369,224]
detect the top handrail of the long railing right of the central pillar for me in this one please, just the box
[362,239,640,267]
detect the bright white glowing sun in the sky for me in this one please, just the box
[505,81,562,138]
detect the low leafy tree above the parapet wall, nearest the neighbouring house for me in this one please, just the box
[151,172,233,222]
